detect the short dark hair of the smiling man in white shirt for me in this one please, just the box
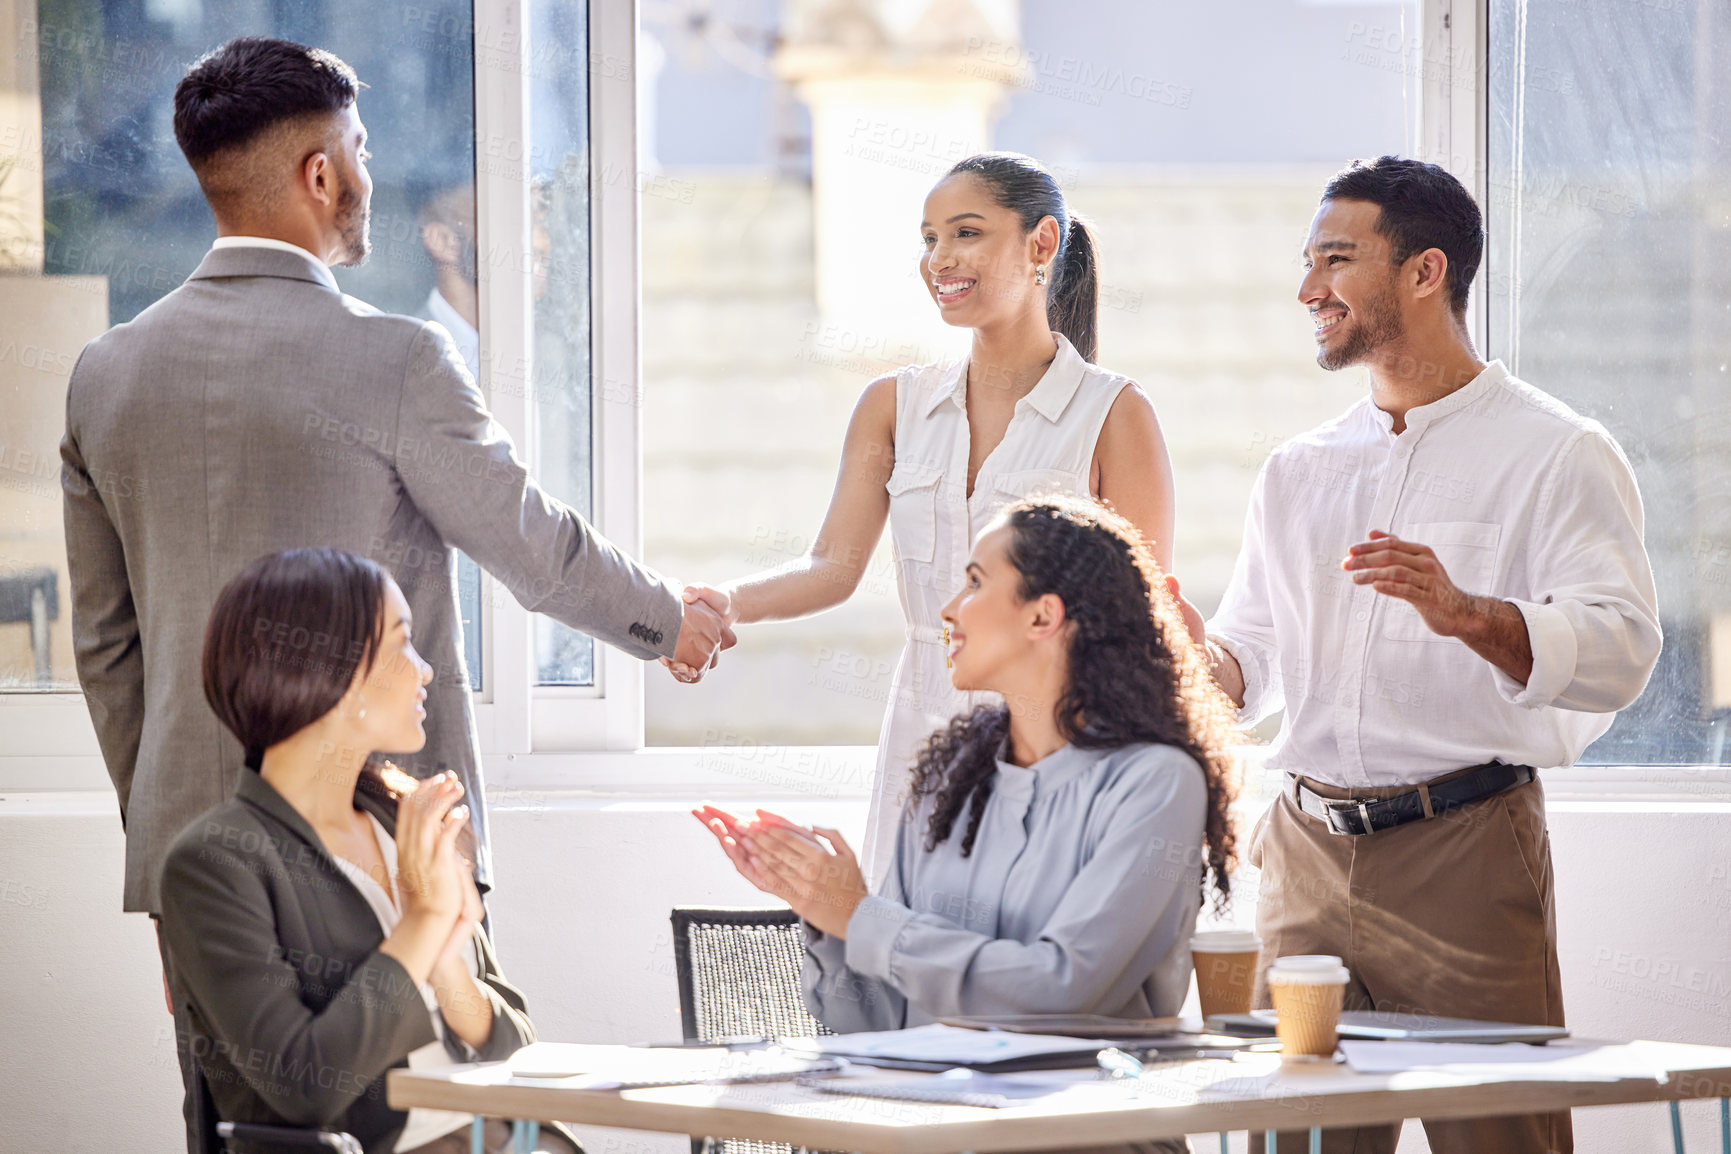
[1322,156,1485,315]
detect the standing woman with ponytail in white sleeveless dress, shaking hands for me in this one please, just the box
[675,152,1177,879]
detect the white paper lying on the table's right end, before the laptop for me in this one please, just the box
[1340,1042,1665,1081]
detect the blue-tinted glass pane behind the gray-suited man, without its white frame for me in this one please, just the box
[0,0,481,690]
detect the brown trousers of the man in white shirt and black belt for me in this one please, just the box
[1250,773,1573,1154]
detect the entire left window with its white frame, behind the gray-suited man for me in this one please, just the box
[0,0,640,768]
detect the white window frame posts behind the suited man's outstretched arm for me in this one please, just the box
[474,0,644,758]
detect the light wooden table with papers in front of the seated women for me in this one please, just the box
[386,1042,1731,1154]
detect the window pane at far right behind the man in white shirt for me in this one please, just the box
[1481,0,1731,765]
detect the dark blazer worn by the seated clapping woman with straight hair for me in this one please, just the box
[163,770,553,1154]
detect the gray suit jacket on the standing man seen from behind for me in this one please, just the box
[61,247,680,912]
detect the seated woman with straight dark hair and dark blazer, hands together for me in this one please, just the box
[163,548,578,1154]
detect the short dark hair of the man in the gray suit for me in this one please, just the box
[175,36,362,171]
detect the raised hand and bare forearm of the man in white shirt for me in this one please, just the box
[1340,529,1532,685]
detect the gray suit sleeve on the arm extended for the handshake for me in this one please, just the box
[396,324,682,659]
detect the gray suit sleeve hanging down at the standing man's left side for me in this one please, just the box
[61,369,144,825]
